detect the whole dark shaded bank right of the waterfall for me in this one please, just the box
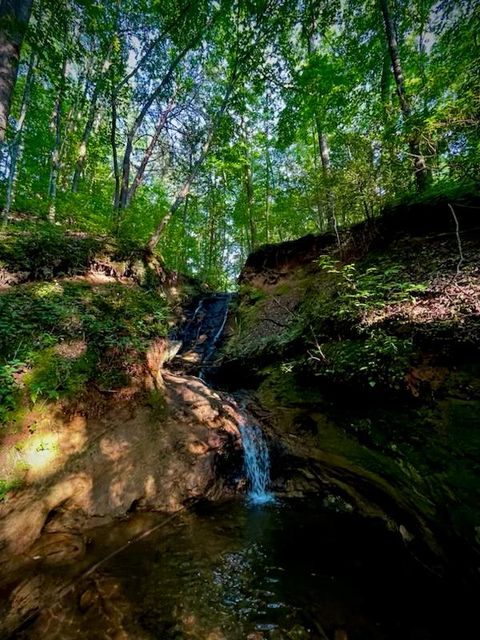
[218,201,480,581]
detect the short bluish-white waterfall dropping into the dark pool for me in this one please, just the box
[239,421,274,504]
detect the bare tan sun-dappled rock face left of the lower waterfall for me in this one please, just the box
[0,370,238,563]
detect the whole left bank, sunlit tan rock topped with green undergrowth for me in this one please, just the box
[0,234,238,564]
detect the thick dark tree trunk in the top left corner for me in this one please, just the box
[0,0,33,142]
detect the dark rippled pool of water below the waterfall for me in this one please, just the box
[10,499,476,640]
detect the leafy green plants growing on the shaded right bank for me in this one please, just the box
[296,255,427,391]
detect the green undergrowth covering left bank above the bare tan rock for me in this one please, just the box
[0,280,169,423]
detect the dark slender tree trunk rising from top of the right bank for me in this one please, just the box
[379,0,430,191]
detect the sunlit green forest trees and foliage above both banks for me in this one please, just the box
[0,0,480,286]
